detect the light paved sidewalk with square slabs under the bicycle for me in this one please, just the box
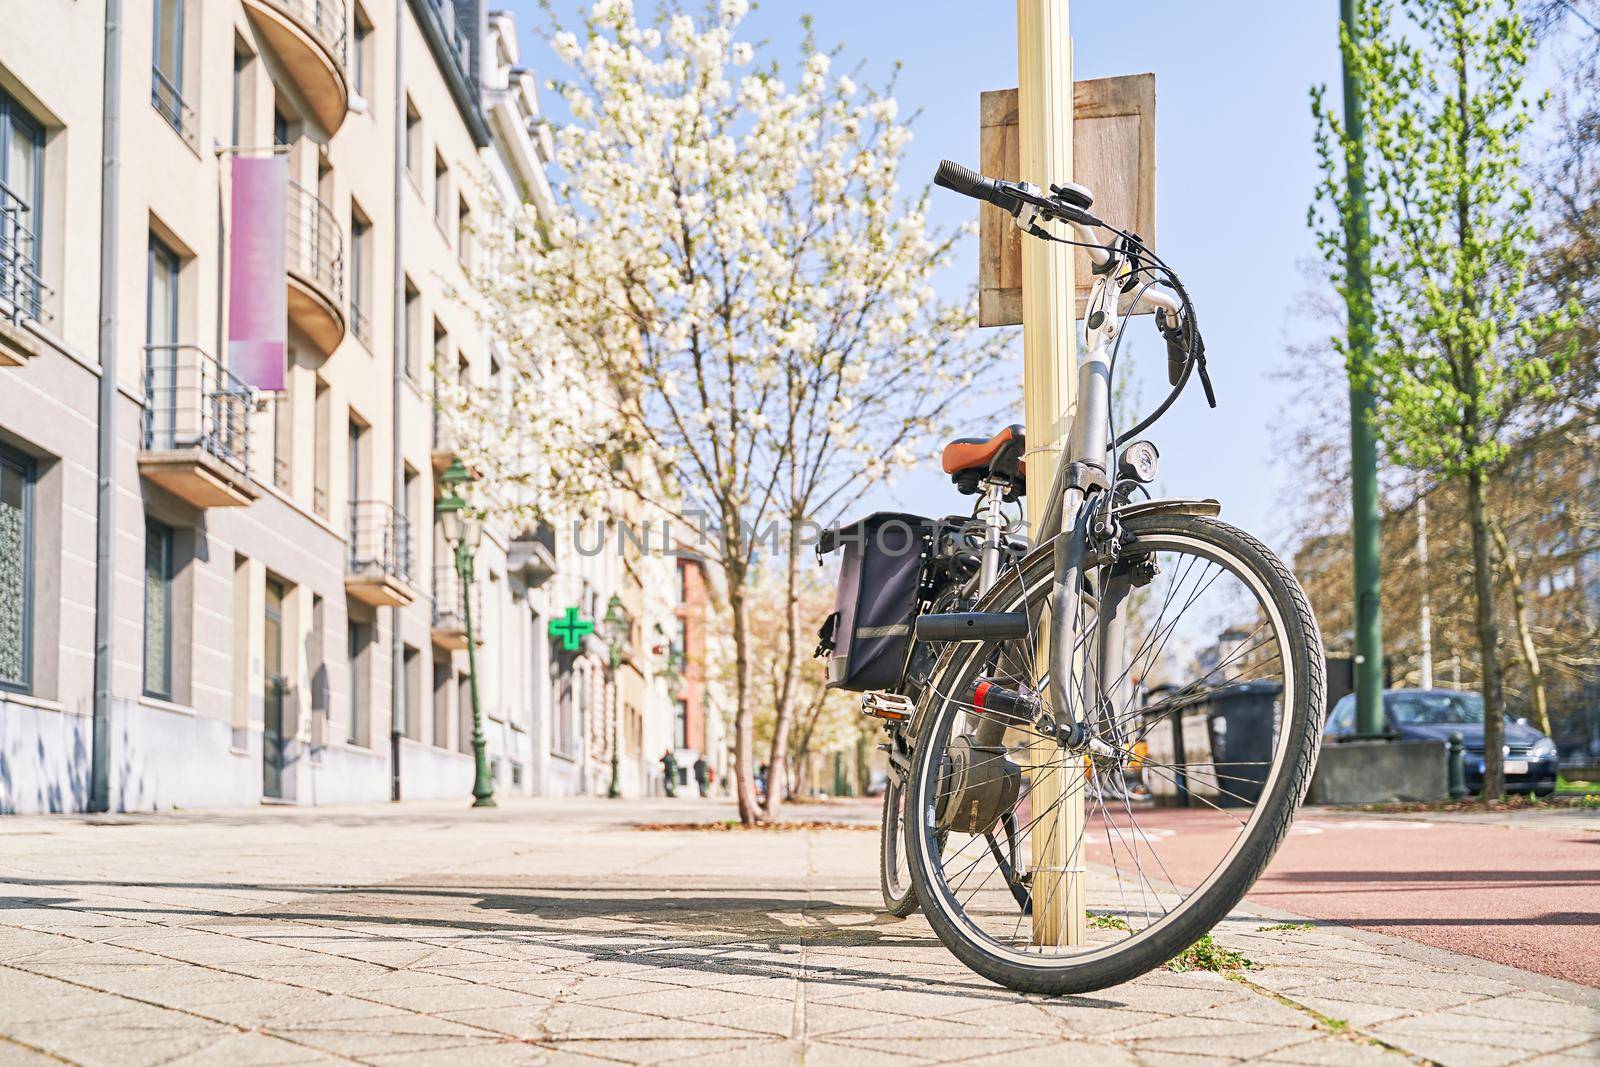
[0,800,1600,1067]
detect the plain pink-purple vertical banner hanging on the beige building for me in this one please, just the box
[227,155,290,392]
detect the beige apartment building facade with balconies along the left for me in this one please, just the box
[0,0,670,811]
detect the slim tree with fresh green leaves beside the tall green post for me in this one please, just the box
[1312,0,1562,797]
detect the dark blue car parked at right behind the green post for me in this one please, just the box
[1323,689,1560,797]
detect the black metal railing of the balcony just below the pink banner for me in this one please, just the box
[142,344,253,477]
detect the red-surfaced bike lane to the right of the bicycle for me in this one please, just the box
[1091,809,1600,987]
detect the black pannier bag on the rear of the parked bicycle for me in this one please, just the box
[816,512,933,693]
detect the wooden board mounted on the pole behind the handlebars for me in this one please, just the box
[978,74,1155,326]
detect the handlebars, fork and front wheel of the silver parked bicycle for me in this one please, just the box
[876,162,1325,993]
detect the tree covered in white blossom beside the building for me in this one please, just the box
[445,0,1000,821]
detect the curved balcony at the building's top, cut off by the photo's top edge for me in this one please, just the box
[245,0,350,138]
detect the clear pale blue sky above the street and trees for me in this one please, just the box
[499,0,1574,549]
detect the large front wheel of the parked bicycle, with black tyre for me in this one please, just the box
[906,512,1323,993]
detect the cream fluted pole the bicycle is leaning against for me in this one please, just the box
[1016,0,1083,945]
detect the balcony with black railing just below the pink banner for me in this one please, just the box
[139,344,261,507]
